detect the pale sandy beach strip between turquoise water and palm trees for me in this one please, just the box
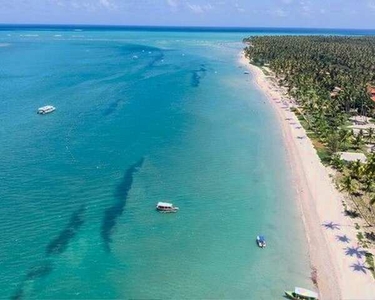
[239,53,375,299]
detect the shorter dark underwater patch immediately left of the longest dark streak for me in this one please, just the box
[46,205,86,255]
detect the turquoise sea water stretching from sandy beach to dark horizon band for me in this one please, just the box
[0,28,352,299]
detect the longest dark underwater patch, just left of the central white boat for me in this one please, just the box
[101,158,144,252]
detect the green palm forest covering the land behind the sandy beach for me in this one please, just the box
[244,36,375,227]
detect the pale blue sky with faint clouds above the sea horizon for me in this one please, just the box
[0,0,375,29]
